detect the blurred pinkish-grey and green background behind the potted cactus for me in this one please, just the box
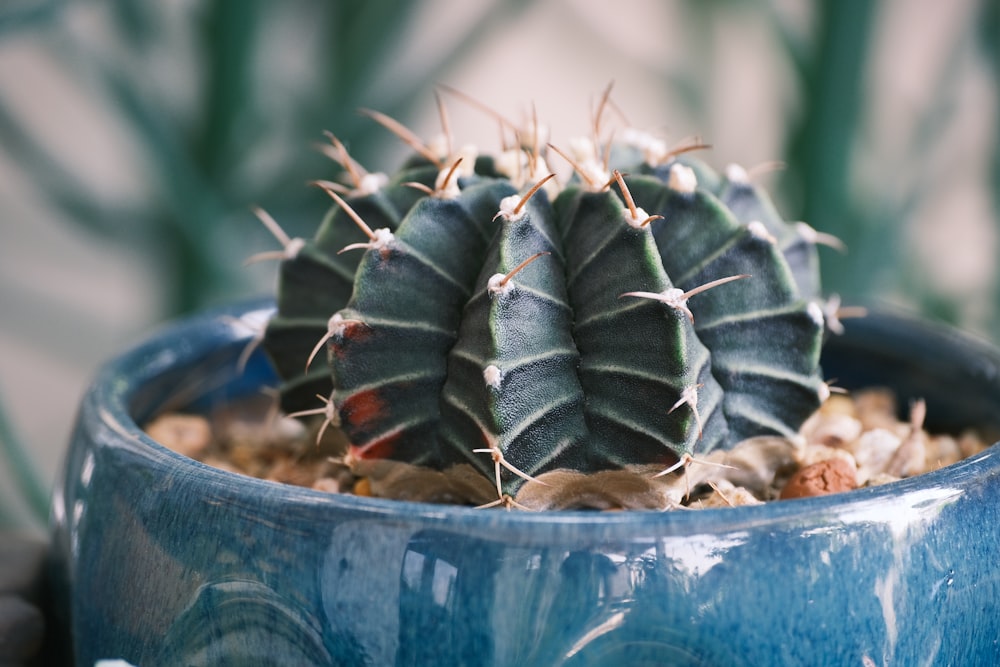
[0,0,1000,531]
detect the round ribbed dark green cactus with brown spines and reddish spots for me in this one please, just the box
[264,95,825,506]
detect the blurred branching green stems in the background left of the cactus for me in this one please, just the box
[0,0,529,317]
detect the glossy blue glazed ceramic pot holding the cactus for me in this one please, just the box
[54,303,1000,667]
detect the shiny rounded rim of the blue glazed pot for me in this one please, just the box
[84,299,1000,534]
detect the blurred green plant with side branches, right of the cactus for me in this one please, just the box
[776,0,1000,325]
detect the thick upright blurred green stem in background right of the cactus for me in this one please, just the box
[786,0,876,300]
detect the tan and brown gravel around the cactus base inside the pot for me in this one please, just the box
[147,389,992,509]
